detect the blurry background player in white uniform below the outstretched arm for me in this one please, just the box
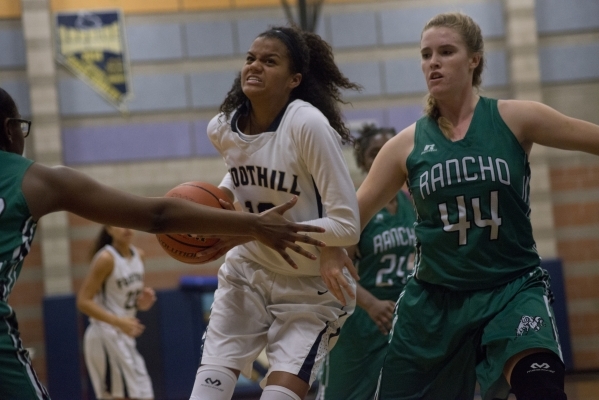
[77,226,156,399]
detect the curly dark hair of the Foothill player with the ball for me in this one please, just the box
[220,26,362,142]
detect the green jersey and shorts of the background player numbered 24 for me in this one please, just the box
[320,192,416,400]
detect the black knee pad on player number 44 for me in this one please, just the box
[511,352,567,400]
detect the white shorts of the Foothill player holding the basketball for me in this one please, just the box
[202,253,355,385]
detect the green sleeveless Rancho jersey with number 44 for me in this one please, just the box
[407,97,540,290]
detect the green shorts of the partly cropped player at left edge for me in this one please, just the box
[0,312,50,400]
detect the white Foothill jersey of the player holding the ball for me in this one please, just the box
[208,100,360,276]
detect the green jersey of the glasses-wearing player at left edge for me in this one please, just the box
[0,151,36,317]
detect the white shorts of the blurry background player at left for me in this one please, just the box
[83,324,154,399]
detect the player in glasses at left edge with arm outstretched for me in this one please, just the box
[0,88,322,400]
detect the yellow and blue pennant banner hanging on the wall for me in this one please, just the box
[56,10,131,111]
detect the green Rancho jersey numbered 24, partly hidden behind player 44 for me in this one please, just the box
[356,191,416,301]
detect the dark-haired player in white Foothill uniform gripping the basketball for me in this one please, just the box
[191,27,359,400]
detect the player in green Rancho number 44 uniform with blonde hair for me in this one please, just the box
[344,13,599,400]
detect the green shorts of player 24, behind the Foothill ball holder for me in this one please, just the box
[319,307,389,400]
